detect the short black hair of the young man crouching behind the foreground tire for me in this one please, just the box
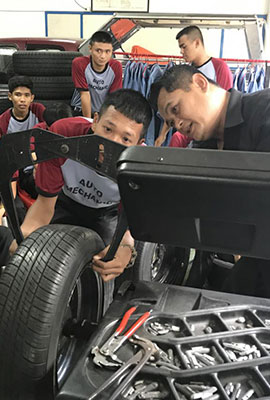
[99,89,152,138]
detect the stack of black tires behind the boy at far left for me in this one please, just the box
[13,51,82,106]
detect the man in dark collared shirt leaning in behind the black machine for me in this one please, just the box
[150,65,270,297]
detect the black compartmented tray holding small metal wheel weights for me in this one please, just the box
[59,282,270,400]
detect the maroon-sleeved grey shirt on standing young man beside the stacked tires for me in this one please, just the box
[71,56,122,112]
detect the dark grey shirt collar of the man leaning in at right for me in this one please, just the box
[225,89,244,129]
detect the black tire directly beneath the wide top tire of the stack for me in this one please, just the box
[31,76,74,100]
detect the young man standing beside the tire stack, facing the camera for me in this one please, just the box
[71,31,122,118]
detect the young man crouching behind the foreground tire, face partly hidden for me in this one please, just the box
[21,89,152,281]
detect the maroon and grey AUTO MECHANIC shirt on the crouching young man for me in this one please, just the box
[36,117,120,208]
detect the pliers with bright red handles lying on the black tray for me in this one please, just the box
[91,307,152,367]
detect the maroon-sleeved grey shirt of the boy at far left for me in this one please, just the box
[0,103,45,137]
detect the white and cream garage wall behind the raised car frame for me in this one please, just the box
[0,0,270,58]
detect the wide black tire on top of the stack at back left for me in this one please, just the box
[13,51,82,76]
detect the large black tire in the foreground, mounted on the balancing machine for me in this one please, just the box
[0,225,104,400]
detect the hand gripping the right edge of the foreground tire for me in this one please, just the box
[92,245,131,282]
